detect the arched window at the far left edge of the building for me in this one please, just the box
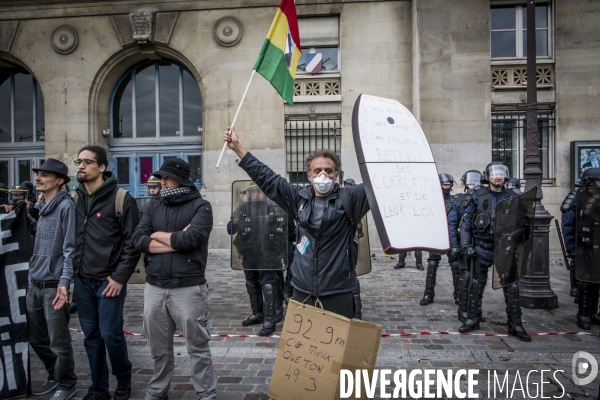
[0,65,46,186]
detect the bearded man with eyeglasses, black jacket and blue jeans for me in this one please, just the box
[74,146,140,400]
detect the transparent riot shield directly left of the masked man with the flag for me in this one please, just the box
[230,181,288,270]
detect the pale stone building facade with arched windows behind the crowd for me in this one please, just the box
[0,0,600,251]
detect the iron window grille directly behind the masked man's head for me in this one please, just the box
[285,119,342,184]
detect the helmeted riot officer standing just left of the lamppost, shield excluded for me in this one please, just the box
[459,162,531,342]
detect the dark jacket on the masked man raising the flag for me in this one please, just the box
[239,153,369,296]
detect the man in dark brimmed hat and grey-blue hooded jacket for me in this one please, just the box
[27,158,77,400]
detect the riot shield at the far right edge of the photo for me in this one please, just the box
[575,189,600,283]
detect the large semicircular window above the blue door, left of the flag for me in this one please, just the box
[110,60,202,139]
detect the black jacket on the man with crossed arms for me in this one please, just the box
[133,188,213,288]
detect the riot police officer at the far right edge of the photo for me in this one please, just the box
[561,168,600,330]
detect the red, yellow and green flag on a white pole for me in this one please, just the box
[254,0,301,104]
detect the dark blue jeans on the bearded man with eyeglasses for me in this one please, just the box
[75,276,131,394]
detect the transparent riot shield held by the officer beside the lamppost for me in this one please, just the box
[492,188,537,289]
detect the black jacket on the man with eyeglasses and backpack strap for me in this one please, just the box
[73,171,140,284]
